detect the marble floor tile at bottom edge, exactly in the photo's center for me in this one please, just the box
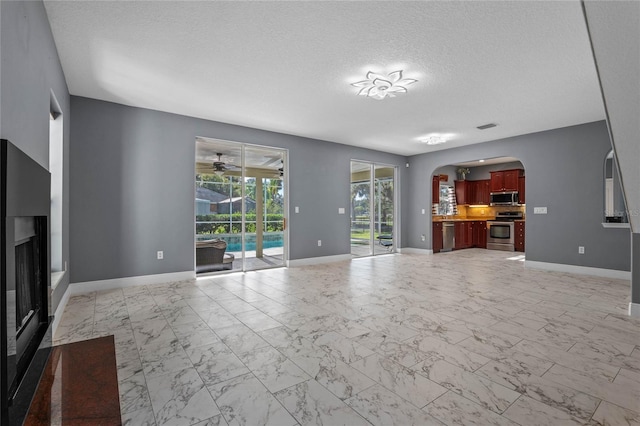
[275,380,369,426]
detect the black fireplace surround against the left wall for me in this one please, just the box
[0,139,53,425]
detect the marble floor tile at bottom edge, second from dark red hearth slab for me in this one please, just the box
[148,369,220,426]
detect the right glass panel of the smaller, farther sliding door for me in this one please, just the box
[373,164,395,254]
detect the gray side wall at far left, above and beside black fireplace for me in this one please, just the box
[0,1,71,310]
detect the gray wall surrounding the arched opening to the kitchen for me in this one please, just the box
[403,121,631,271]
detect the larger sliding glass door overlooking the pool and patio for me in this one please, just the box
[195,138,287,273]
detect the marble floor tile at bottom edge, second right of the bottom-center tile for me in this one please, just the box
[423,391,517,426]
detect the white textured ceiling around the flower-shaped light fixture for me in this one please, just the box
[45,0,604,155]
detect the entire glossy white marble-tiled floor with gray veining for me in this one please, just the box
[56,249,640,425]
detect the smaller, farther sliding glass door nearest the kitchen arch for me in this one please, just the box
[351,161,396,257]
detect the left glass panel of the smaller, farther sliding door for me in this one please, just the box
[351,161,373,257]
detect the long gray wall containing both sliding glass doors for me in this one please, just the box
[70,96,409,282]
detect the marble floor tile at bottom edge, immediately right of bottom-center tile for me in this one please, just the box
[345,385,442,426]
